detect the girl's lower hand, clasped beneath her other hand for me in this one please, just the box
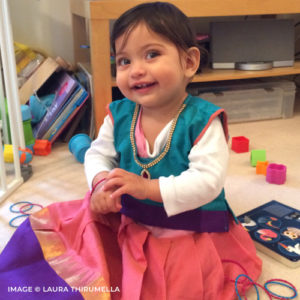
[90,181,122,214]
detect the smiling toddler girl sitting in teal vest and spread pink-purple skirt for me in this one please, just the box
[0,2,261,300]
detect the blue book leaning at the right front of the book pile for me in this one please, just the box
[42,84,89,143]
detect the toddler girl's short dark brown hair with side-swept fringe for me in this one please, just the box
[111,2,197,53]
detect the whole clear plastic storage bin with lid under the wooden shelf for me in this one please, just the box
[188,78,296,122]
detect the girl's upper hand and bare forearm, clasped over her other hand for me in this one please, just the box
[103,168,151,200]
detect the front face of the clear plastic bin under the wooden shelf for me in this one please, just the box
[199,88,283,123]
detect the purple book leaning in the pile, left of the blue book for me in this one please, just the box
[33,71,79,139]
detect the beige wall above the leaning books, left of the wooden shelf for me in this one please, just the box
[8,0,74,63]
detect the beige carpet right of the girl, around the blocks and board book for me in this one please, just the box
[225,99,300,299]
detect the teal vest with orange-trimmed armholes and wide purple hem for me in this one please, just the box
[109,95,233,232]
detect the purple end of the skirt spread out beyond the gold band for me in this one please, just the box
[0,219,83,300]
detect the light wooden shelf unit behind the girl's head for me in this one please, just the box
[70,0,300,130]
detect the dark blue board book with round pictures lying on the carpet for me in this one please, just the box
[238,200,300,268]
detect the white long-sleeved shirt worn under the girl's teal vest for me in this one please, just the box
[84,116,229,216]
